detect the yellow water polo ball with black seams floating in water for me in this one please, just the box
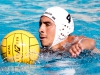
[1,30,40,64]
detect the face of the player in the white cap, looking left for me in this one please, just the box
[39,16,56,46]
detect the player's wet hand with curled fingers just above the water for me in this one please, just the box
[69,43,83,57]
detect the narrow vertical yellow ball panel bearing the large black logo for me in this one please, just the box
[12,33,23,62]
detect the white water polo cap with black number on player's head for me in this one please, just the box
[42,6,74,47]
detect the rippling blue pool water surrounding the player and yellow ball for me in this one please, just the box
[0,0,100,75]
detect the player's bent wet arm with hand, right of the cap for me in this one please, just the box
[69,36,99,57]
